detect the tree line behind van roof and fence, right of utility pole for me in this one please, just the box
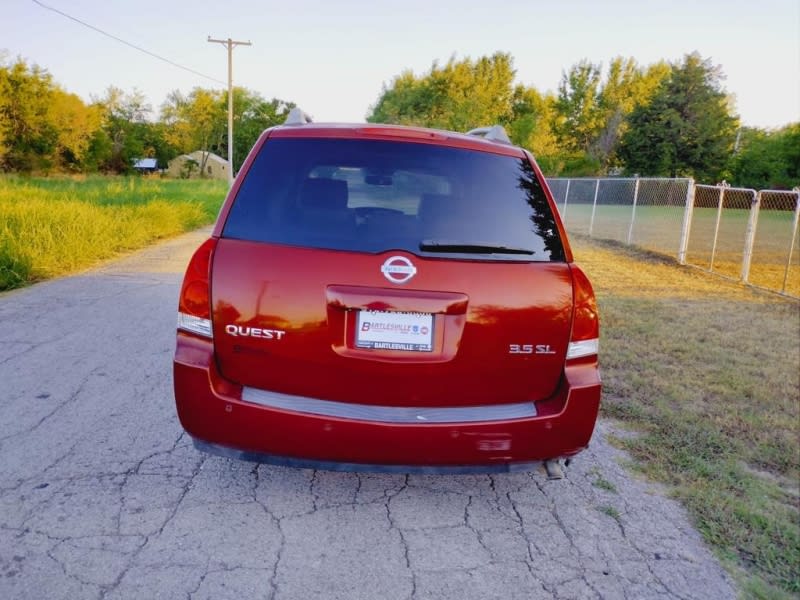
[368,53,800,189]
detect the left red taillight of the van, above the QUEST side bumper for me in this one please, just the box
[178,238,217,338]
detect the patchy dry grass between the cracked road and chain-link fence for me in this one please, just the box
[572,236,800,598]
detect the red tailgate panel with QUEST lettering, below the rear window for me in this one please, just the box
[211,238,572,407]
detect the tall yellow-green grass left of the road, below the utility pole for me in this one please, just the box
[0,176,228,290]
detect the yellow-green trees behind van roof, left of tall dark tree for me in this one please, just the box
[367,53,670,176]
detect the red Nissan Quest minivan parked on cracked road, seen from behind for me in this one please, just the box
[174,110,601,472]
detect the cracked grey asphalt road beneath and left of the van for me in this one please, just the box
[0,230,736,600]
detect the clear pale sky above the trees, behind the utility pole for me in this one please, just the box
[0,0,800,127]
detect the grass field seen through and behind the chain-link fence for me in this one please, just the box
[565,204,800,297]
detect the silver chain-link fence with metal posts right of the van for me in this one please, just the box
[548,178,800,298]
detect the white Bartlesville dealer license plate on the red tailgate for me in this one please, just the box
[356,310,433,352]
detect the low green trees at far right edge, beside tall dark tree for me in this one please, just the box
[730,123,800,190]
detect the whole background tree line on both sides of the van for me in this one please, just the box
[0,52,800,189]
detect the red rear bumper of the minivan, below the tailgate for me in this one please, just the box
[174,332,601,473]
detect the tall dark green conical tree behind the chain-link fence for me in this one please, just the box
[619,53,737,181]
